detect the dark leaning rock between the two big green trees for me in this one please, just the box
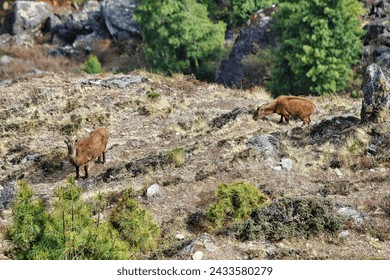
[216,7,276,86]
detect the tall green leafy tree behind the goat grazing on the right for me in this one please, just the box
[270,0,364,96]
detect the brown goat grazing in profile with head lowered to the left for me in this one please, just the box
[255,96,317,125]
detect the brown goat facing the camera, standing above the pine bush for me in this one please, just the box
[65,127,109,179]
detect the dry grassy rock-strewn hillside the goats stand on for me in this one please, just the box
[0,71,390,259]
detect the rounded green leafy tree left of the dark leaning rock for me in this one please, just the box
[135,0,225,79]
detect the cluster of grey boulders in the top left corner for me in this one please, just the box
[0,0,140,54]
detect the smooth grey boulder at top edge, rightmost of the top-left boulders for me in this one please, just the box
[102,0,140,41]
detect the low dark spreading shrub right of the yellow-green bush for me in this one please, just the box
[233,198,345,241]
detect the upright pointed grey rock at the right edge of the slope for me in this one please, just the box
[360,63,390,123]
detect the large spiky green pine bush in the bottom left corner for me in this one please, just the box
[5,177,130,260]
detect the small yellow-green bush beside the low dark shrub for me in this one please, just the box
[207,182,270,229]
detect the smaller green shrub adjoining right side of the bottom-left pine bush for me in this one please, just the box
[110,189,160,253]
